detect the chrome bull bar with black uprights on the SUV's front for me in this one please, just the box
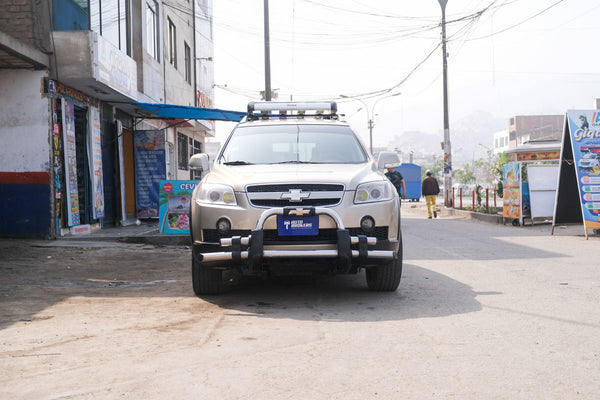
[199,207,397,269]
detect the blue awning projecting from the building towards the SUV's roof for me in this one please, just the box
[133,102,246,122]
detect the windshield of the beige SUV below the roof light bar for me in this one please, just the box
[219,125,367,165]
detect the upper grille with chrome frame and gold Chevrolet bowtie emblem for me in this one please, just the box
[246,183,344,208]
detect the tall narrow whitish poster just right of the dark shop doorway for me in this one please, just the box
[88,106,104,219]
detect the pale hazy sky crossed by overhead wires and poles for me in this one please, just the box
[213,0,600,146]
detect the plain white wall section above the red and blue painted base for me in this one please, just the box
[0,70,50,172]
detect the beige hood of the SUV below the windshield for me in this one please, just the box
[203,162,387,192]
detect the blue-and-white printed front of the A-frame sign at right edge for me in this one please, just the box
[567,110,600,230]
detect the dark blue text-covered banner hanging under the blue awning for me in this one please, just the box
[133,130,167,218]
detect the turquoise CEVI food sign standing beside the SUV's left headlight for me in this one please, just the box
[159,180,198,235]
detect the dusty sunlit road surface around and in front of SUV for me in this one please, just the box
[0,209,600,400]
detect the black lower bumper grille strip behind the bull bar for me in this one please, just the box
[202,226,388,245]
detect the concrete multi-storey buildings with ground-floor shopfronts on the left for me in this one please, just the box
[0,0,214,238]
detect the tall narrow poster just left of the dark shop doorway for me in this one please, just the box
[62,98,80,226]
